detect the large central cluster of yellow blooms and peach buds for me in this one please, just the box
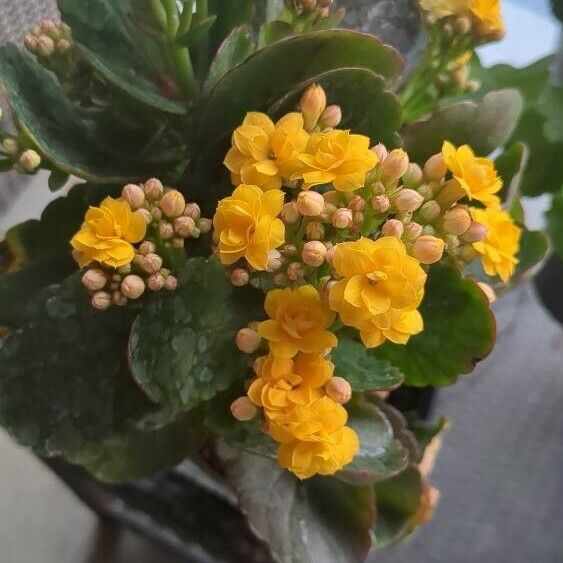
[214,85,520,477]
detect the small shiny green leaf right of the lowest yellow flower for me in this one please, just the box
[337,402,419,485]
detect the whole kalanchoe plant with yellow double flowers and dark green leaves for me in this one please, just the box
[0,0,544,562]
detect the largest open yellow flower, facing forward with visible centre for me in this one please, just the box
[329,237,426,327]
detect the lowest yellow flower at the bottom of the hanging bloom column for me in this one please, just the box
[268,396,359,479]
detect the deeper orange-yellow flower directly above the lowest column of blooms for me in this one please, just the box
[258,285,338,358]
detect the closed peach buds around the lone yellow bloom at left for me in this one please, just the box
[82,178,211,310]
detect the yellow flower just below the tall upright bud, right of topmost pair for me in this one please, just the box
[292,129,379,192]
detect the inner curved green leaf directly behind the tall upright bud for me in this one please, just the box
[268,68,401,146]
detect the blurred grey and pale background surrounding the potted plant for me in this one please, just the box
[0,0,563,563]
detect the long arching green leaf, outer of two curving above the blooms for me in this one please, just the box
[197,30,403,146]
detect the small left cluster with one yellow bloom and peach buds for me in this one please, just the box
[70,178,211,310]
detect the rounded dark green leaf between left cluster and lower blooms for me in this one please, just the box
[129,258,263,410]
